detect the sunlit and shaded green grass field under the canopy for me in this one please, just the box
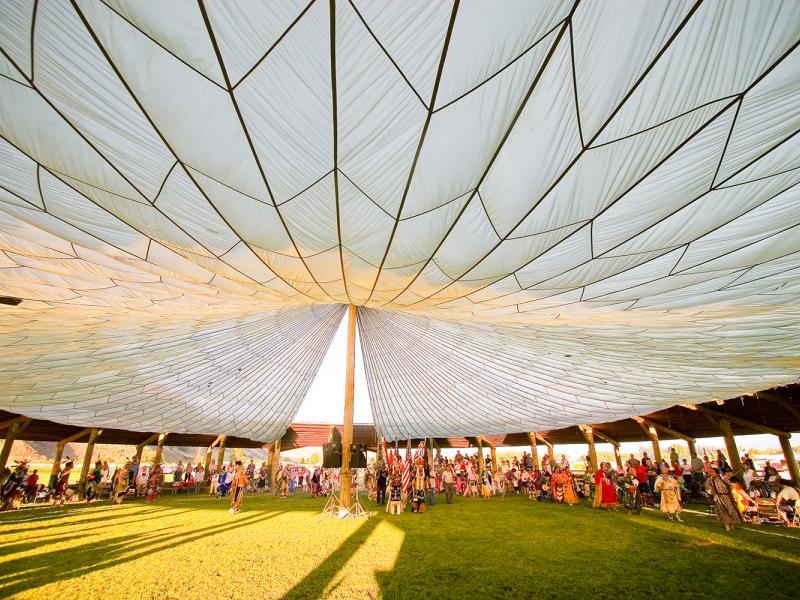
[0,496,800,600]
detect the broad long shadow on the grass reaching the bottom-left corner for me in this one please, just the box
[0,511,281,597]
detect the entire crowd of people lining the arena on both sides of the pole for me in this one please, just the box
[3,444,800,529]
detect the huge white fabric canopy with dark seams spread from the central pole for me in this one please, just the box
[0,0,800,440]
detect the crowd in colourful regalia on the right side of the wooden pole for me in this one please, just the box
[358,444,800,530]
